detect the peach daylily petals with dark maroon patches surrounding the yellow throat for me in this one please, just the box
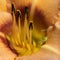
[0,0,60,60]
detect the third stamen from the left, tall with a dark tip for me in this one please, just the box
[24,7,29,47]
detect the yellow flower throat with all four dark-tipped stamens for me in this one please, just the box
[6,4,47,55]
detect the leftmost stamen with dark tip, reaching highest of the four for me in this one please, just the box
[11,4,18,45]
